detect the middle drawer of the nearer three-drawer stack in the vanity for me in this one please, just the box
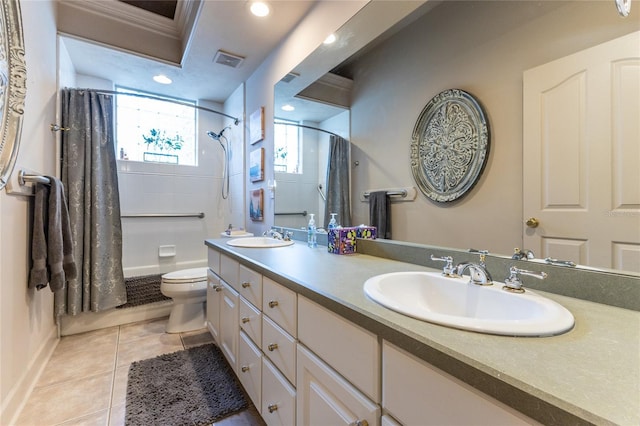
[262,316,296,383]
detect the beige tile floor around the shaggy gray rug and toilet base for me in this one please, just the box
[16,318,264,426]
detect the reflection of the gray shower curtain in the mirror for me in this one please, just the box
[324,135,351,230]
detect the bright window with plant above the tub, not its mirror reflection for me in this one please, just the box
[116,87,198,166]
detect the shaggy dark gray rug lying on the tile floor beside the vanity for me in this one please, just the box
[125,344,249,426]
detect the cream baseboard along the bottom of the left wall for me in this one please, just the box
[0,327,59,425]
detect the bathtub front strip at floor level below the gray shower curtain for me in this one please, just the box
[60,300,173,336]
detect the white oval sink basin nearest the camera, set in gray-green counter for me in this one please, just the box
[364,272,574,336]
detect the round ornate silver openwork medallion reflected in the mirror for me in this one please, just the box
[411,89,489,203]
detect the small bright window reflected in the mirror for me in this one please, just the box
[273,119,302,174]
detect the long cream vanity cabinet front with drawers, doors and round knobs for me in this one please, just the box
[207,246,538,426]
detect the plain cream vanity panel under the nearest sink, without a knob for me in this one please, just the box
[382,341,539,426]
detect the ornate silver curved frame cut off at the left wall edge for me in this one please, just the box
[0,0,27,189]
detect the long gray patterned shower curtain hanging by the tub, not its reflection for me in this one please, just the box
[55,89,127,315]
